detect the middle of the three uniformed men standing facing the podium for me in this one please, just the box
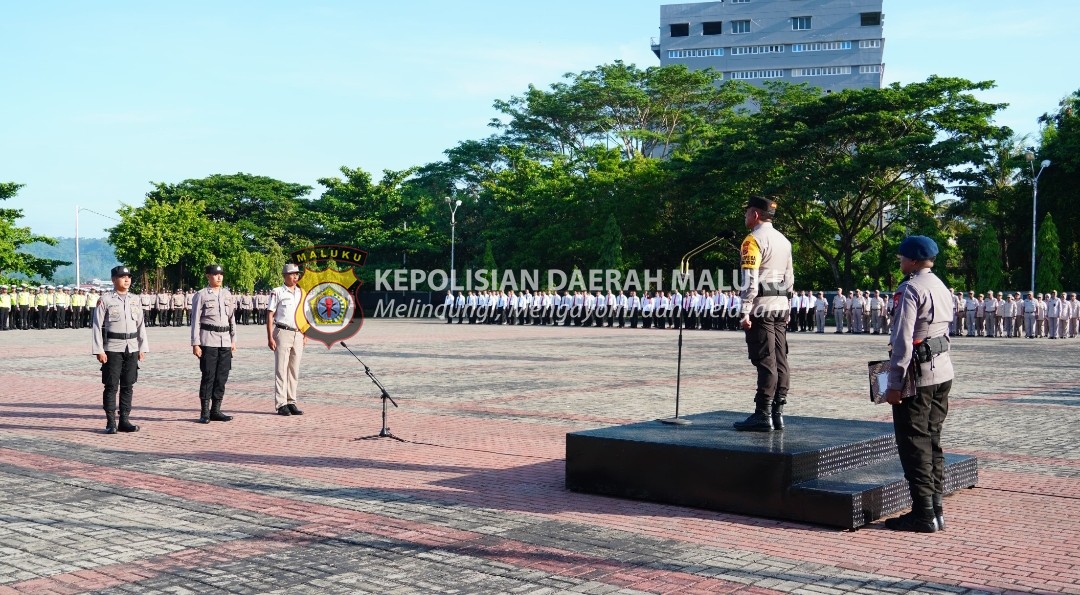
[191,265,237,423]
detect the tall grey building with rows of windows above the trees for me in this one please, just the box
[652,0,885,93]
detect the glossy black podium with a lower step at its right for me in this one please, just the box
[566,411,978,529]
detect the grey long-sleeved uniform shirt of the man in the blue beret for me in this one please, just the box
[889,269,955,390]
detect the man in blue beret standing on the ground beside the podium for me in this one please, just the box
[885,235,955,533]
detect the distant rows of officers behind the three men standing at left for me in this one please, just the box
[0,285,270,330]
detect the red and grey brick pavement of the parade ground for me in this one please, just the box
[0,321,1080,594]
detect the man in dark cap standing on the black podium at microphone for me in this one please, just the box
[734,197,795,432]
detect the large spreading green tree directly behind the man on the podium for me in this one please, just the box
[686,77,1009,287]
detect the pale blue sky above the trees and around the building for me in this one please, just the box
[0,0,1080,238]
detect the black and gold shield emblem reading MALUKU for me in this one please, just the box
[292,246,367,349]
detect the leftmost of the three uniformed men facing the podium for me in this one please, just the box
[91,265,149,434]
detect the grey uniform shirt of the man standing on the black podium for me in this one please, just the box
[740,221,795,316]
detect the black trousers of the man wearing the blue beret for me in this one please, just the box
[892,380,953,500]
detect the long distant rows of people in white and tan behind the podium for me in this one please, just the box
[432,288,1080,339]
